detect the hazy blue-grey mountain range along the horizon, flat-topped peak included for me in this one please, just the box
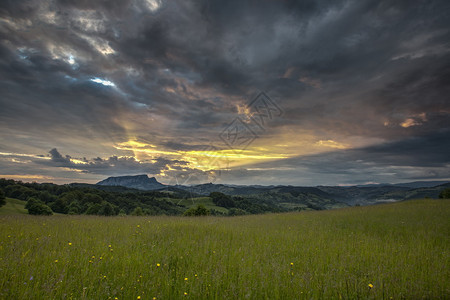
[97,175,450,209]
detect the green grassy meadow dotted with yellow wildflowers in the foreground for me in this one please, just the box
[0,200,450,299]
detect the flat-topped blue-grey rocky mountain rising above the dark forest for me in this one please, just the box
[97,174,166,191]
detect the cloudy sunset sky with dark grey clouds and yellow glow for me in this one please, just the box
[0,0,450,186]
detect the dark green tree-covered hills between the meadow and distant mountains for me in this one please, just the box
[0,179,288,216]
